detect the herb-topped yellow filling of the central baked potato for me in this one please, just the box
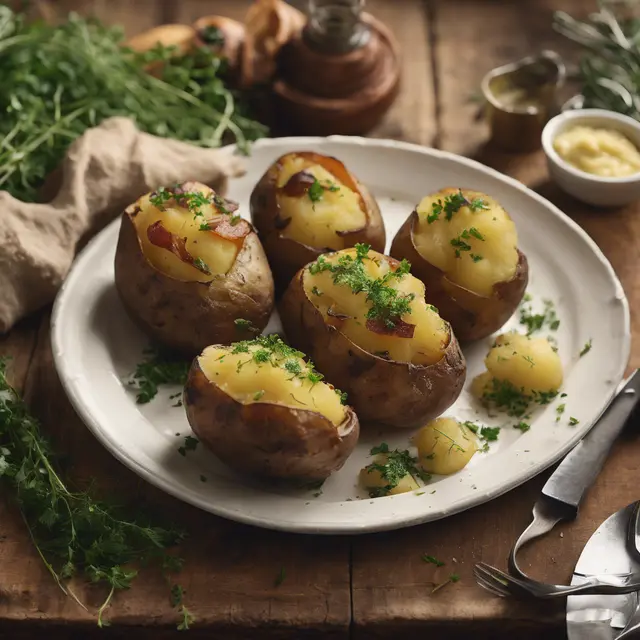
[303,245,451,365]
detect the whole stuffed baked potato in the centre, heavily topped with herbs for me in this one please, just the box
[280,244,466,427]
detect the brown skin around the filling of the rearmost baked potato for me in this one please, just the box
[250,152,386,294]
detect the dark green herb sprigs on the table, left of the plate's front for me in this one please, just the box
[0,359,184,626]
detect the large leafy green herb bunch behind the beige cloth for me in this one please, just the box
[0,6,267,201]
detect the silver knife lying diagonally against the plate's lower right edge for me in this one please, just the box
[509,369,640,577]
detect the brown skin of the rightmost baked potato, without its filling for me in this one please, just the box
[389,211,529,343]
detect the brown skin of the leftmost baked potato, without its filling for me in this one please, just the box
[115,205,274,357]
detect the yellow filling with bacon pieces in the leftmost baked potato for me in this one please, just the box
[133,185,241,282]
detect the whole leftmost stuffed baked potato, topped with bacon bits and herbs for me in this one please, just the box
[115,182,274,356]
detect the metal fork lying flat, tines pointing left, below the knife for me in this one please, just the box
[473,562,640,600]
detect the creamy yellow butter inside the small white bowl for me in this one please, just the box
[553,126,640,178]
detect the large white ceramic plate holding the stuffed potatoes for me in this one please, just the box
[52,137,630,534]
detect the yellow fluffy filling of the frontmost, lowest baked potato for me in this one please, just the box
[198,345,346,426]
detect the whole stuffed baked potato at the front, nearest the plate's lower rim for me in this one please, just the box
[184,335,360,482]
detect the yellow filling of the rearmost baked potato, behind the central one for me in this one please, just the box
[276,155,367,250]
